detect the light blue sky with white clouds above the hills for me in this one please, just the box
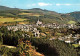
[0,0,80,13]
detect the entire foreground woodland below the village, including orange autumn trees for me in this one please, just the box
[0,27,80,56]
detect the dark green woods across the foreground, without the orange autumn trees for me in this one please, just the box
[0,27,79,56]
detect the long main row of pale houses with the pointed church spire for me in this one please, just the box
[7,20,78,32]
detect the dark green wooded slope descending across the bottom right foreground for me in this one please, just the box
[32,39,78,56]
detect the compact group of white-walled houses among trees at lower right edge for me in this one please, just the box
[58,34,80,44]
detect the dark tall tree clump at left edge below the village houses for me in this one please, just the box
[0,27,24,46]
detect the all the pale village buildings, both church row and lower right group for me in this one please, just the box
[7,19,80,45]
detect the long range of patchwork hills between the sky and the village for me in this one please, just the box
[0,6,80,24]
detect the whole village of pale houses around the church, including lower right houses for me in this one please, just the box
[7,19,80,43]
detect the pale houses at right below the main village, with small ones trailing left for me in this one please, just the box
[50,34,80,45]
